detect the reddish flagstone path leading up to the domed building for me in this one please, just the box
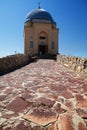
[0,60,87,130]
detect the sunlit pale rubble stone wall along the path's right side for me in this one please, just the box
[57,55,87,74]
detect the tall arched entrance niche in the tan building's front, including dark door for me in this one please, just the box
[38,31,48,55]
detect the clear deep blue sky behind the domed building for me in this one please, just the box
[0,0,87,57]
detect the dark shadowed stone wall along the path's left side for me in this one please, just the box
[0,54,29,75]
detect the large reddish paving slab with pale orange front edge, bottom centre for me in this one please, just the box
[23,108,57,126]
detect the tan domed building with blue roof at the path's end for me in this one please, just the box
[24,8,59,56]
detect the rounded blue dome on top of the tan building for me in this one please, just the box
[25,9,55,24]
